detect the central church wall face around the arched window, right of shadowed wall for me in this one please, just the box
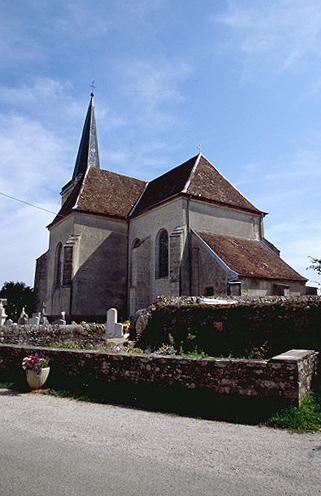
[129,199,186,315]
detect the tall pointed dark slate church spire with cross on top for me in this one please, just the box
[72,93,100,179]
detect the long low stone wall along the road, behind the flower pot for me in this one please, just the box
[0,345,318,405]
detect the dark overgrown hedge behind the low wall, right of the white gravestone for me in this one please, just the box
[136,296,321,359]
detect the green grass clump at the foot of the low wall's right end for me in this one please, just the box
[264,391,321,433]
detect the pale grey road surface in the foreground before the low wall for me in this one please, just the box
[0,389,321,496]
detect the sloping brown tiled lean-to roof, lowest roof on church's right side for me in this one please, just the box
[197,232,307,282]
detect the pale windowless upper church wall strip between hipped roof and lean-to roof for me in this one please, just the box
[189,199,263,239]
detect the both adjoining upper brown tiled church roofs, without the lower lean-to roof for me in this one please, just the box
[54,154,262,227]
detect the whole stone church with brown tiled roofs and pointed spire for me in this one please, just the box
[34,94,307,321]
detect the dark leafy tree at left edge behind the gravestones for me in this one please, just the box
[0,281,33,322]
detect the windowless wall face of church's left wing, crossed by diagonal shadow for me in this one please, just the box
[72,213,127,315]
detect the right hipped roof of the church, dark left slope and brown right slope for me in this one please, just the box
[133,154,263,215]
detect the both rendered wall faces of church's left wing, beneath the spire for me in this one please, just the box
[47,212,127,317]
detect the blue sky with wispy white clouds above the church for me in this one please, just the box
[0,0,321,287]
